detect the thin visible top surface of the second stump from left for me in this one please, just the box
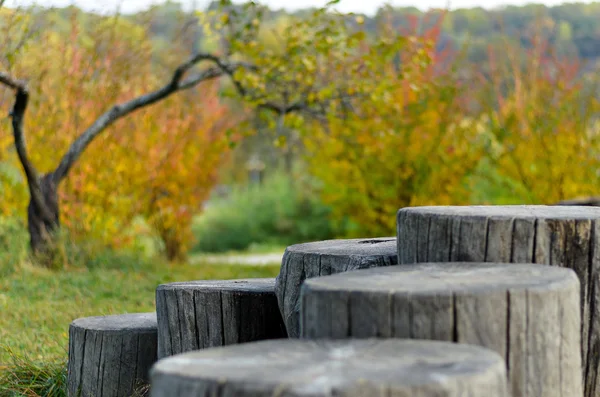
[157,278,275,292]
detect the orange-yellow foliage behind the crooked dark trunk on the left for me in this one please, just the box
[0,11,235,259]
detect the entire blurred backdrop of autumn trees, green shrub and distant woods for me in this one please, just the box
[0,1,600,261]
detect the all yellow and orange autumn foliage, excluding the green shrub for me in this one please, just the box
[0,1,600,254]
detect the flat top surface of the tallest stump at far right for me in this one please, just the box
[398,205,600,219]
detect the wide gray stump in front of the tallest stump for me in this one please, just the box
[301,263,583,397]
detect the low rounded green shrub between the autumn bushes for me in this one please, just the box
[194,174,344,252]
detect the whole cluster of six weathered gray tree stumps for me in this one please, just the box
[69,206,600,397]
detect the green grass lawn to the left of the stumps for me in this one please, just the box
[0,255,279,397]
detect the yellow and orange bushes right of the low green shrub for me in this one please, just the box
[305,10,600,236]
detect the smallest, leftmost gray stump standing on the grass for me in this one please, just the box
[67,313,157,397]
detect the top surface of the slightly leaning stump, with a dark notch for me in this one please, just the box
[286,237,398,256]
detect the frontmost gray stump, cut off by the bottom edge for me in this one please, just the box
[151,339,508,397]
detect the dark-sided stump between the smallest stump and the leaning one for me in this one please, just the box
[156,278,286,358]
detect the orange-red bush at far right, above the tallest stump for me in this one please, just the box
[478,31,600,204]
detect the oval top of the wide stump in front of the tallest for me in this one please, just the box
[305,262,579,295]
